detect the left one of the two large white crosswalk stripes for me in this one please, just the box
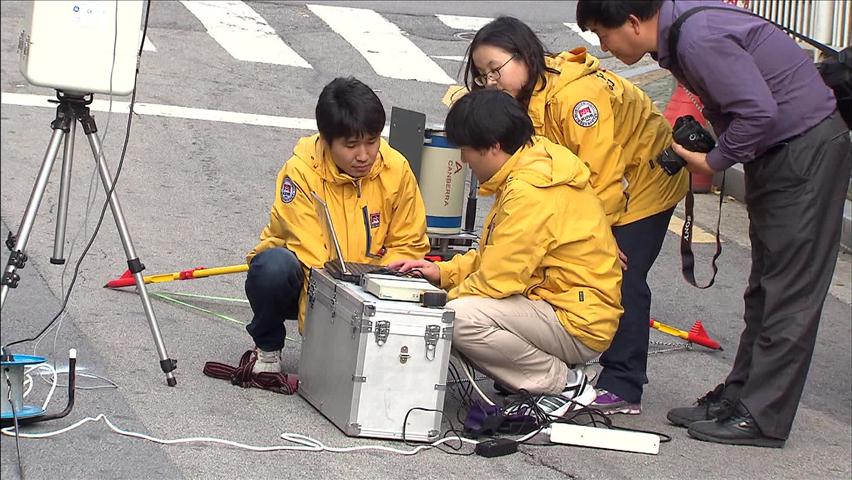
[180,1,311,68]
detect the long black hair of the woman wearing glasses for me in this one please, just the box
[464,17,559,105]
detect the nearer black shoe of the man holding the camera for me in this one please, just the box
[687,403,785,448]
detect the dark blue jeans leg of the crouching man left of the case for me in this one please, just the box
[246,247,305,352]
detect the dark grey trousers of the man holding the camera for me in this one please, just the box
[725,112,852,439]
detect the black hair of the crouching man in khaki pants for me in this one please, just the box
[444,90,535,155]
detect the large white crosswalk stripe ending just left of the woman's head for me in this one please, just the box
[307,5,455,85]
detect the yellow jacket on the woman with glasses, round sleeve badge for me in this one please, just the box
[529,48,689,225]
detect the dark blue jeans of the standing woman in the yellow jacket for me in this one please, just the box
[595,207,674,403]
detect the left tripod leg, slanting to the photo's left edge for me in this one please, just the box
[0,127,65,308]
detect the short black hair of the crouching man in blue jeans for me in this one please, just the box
[315,77,385,144]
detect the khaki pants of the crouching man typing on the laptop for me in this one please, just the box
[447,295,600,394]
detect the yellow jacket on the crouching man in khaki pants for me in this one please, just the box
[437,137,622,352]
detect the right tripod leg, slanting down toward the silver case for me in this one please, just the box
[80,124,177,387]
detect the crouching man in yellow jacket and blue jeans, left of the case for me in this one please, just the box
[246,77,429,373]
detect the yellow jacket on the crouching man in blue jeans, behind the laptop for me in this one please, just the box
[246,134,429,332]
